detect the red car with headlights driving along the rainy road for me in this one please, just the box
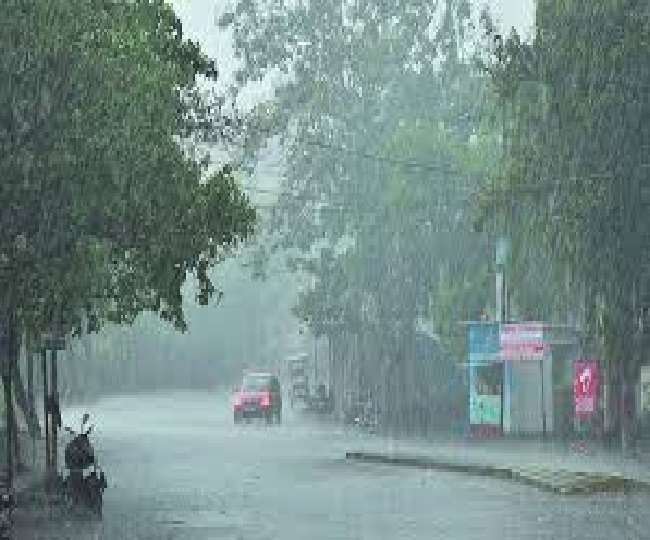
[233,373,282,424]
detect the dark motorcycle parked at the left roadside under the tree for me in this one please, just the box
[62,413,107,517]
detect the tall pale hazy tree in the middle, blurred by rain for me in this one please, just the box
[222,0,496,430]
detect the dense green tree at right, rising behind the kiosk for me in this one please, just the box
[476,0,650,446]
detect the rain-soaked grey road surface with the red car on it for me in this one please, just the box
[13,394,650,540]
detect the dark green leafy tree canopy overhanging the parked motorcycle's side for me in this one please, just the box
[0,0,255,338]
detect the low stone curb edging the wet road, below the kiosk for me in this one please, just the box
[345,452,650,495]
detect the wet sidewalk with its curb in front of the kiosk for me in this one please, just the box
[346,437,650,494]
